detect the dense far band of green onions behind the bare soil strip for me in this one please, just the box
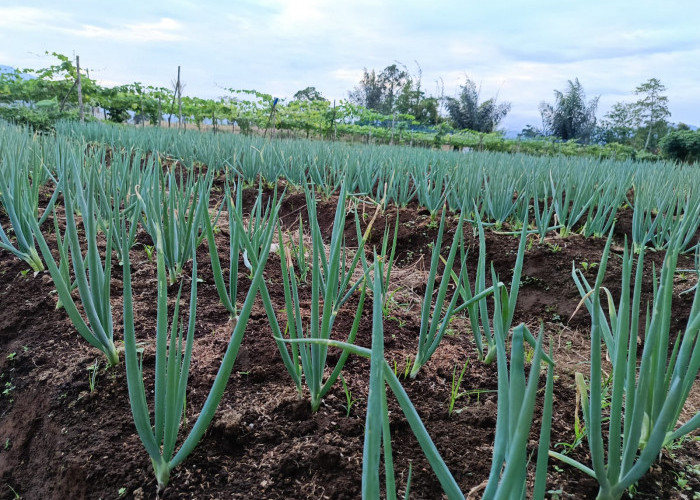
[57,123,700,253]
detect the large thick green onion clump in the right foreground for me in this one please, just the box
[549,234,700,500]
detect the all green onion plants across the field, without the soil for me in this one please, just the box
[0,122,700,500]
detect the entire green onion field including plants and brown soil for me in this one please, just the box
[0,122,700,500]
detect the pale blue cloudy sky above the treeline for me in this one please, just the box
[0,0,700,130]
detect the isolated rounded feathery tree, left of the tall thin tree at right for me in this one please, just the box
[540,78,600,143]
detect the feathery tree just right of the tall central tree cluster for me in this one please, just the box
[446,78,511,133]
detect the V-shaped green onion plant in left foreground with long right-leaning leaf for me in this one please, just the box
[121,187,279,493]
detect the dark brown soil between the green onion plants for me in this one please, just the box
[0,190,700,499]
